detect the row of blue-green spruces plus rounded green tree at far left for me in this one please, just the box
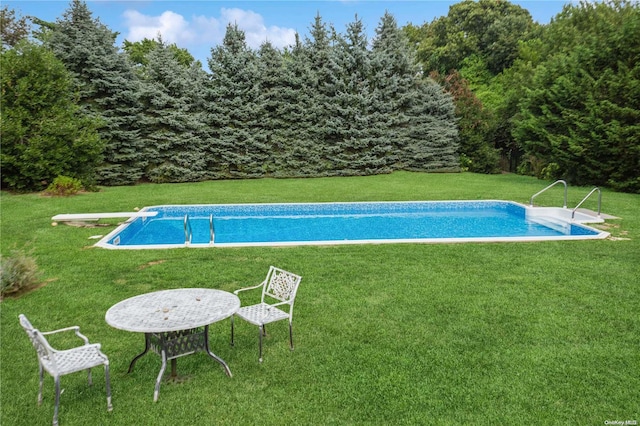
[2,0,459,190]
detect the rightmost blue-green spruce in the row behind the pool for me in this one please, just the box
[372,13,459,171]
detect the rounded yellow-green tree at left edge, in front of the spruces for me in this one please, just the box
[0,41,103,191]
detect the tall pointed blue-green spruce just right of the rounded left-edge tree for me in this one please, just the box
[46,0,146,185]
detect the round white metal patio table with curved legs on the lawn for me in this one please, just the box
[105,288,240,402]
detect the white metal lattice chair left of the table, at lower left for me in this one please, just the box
[19,314,113,426]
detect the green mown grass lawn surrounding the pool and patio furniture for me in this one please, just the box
[0,173,640,426]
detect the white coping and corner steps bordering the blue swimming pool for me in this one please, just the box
[94,200,610,250]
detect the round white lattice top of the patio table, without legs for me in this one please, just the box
[105,288,240,333]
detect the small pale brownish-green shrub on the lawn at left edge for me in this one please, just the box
[0,250,40,297]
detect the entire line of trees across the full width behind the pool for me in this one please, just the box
[0,0,640,193]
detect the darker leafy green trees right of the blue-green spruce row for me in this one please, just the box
[403,0,640,193]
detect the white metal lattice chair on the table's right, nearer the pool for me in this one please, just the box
[231,266,302,362]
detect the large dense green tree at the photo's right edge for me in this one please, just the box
[514,1,640,192]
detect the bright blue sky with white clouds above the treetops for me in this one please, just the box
[0,0,570,68]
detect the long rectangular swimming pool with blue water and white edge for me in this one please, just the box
[96,200,609,249]
